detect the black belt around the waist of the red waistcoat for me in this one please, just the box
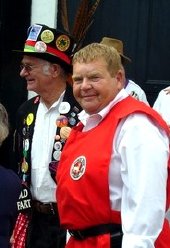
[68,223,122,240]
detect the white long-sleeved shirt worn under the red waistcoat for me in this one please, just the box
[80,89,169,248]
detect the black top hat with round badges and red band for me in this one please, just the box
[14,24,75,72]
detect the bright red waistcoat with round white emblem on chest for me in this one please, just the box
[56,97,170,248]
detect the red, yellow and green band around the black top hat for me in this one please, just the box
[24,40,71,64]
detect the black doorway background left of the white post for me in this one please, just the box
[0,0,31,168]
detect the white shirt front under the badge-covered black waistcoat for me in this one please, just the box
[31,93,64,203]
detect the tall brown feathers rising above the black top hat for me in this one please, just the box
[60,0,100,50]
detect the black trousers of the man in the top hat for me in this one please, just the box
[26,211,66,248]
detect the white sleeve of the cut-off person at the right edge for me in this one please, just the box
[153,86,170,125]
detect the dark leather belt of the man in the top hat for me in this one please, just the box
[32,201,58,214]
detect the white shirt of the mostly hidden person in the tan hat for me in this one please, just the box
[125,79,149,105]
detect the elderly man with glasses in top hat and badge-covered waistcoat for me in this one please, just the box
[13,24,81,248]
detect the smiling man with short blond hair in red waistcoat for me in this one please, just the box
[57,43,170,248]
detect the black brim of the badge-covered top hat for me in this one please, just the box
[13,50,72,73]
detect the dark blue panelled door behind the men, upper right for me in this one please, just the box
[58,0,170,106]
